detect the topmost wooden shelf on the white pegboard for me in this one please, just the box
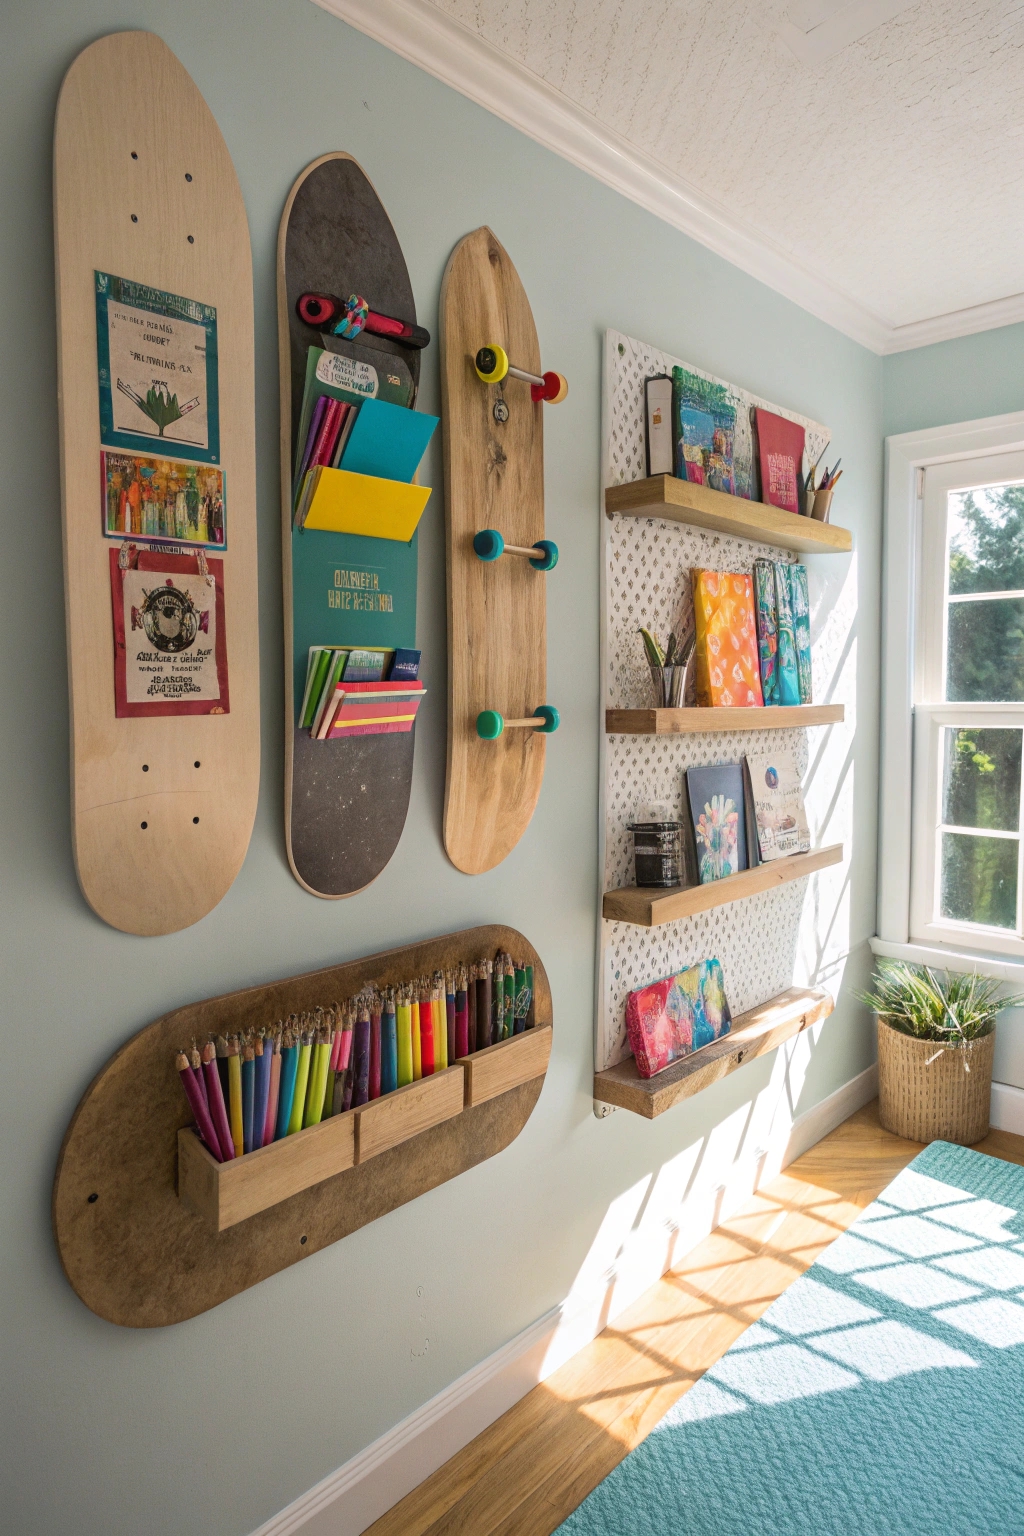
[605,475,854,554]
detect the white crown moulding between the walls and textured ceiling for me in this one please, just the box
[316,0,1024,355]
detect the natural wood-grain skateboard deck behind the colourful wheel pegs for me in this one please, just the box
[439,229,547,874]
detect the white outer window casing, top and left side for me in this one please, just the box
[877,410,1024,952]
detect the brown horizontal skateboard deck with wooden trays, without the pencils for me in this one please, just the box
[52,926,551,1327]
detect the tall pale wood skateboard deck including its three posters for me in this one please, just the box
[54,32,259,934]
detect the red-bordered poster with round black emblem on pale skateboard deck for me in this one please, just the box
[111,545,230,719]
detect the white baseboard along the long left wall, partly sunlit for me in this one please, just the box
[253,1066,878,1536]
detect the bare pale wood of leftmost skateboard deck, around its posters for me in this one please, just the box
[54,32,259,934]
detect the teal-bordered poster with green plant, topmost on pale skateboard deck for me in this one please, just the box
[95,272,220,464]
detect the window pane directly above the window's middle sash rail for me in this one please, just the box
[946,598,1024,703]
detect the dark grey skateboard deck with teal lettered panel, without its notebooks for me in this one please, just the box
[278,154,419,899]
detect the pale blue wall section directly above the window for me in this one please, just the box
[881,324,1024,438]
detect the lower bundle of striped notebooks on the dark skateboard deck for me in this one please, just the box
[299,645,427,742]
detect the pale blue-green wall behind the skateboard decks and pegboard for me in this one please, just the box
[0,0,883,1536]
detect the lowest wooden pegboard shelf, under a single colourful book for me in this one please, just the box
[594,986,835,1120]
